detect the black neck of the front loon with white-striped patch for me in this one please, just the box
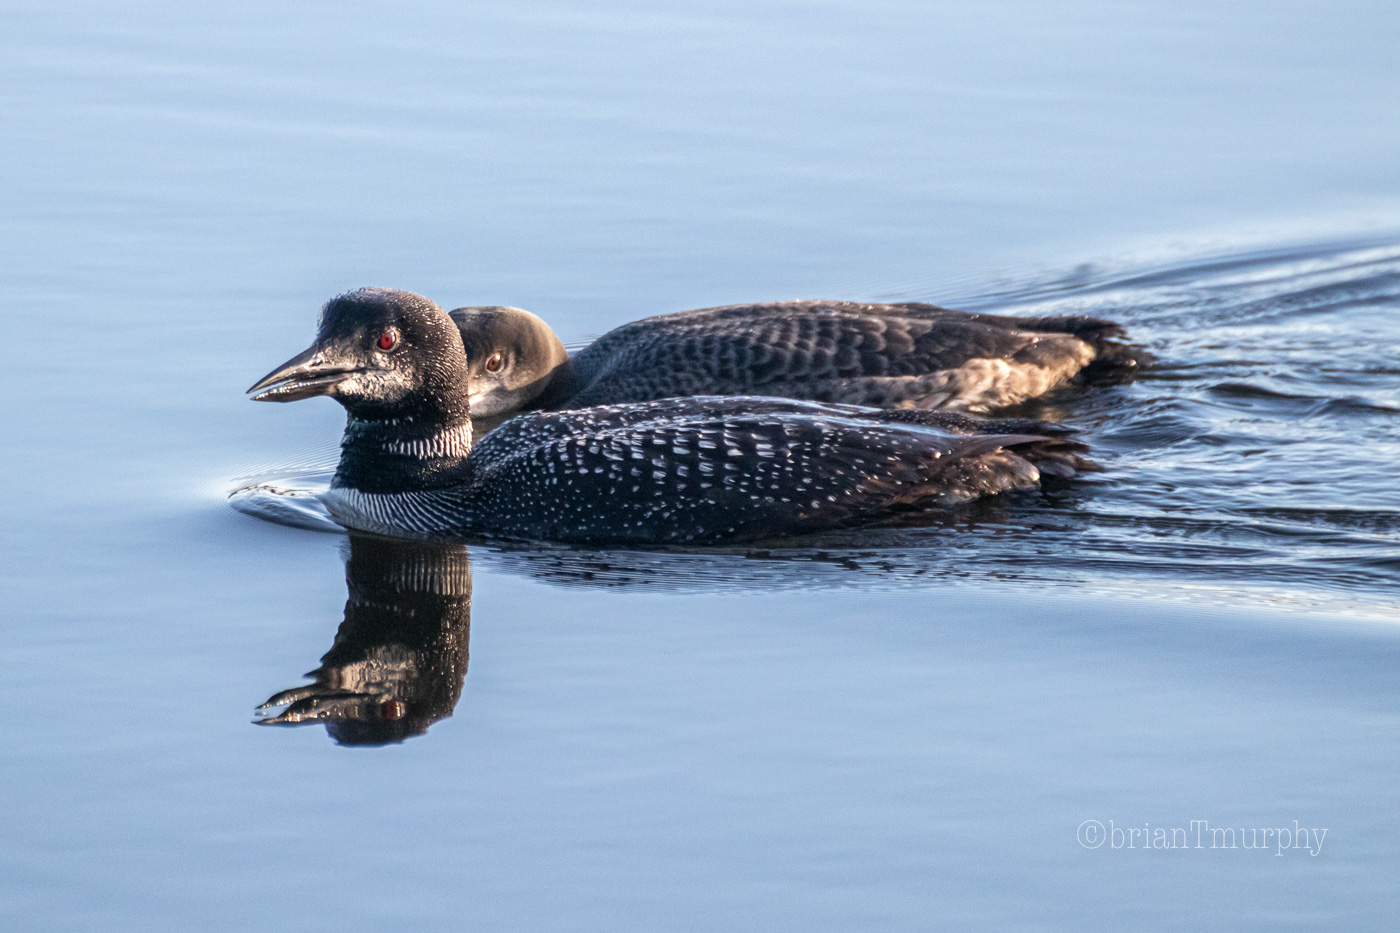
[330,415,472,493]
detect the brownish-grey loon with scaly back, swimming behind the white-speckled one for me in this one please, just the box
[451,301,1145,416]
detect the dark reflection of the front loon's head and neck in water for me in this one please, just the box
[253,535,472,745]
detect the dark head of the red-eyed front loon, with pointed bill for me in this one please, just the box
[248,289,468,419]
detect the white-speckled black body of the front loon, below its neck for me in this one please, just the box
[329,398,1091,545]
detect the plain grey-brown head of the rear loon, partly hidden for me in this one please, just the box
[451,304,571,417]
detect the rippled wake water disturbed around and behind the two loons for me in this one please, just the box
[235,233,1400,608]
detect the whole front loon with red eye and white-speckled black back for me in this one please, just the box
[249,289,1092,545]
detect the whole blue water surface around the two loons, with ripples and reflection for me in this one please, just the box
[0,1,1400,930]
